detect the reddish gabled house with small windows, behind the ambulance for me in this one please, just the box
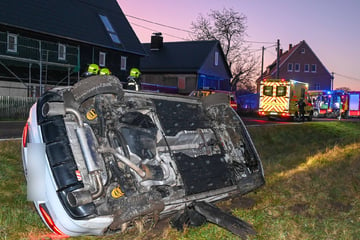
[256,41,333,90]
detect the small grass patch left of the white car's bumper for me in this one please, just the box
[0,141,46,240]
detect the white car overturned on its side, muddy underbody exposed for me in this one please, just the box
[22,75,264,238]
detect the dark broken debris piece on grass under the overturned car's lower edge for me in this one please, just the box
[170,202,256,240]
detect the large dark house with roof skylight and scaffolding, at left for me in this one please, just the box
[0,0,145,96]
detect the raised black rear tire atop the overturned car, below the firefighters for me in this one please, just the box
[71,75,124,104]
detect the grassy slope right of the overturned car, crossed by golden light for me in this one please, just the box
[246,122,360,240]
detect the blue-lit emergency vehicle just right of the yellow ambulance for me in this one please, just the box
[309,90,346,117]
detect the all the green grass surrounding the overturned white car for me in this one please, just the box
[0,121,360,240]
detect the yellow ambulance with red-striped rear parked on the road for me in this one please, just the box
[259,79,313,121]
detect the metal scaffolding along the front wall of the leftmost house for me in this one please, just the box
[0,32,80,97]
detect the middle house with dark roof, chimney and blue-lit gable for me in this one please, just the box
[140,33,231,95]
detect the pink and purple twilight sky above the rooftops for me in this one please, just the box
[117,0,360,91]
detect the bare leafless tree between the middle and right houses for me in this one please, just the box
[191,8,258,92]
